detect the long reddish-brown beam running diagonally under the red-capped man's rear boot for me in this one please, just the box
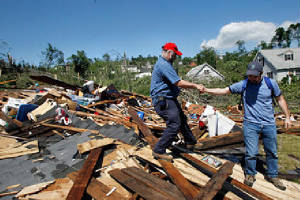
[128,107,198,199]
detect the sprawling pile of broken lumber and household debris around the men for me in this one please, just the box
[0,76,300,199]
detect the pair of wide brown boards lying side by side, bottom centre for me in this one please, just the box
[109,167,184,200]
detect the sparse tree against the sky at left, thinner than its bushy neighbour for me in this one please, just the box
[42,43,64,68]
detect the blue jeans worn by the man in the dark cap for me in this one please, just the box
[243,121,278,178]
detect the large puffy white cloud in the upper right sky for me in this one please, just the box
[201,21,294,49]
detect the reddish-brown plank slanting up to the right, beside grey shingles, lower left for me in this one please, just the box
[67,148,102,200]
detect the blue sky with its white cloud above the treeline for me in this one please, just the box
[0,0,300,64]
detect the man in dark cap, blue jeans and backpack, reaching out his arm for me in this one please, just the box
[203,61,291,190]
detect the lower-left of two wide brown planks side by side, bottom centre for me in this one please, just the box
[109,169,175,200]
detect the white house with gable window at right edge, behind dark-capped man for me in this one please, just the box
[254,48,300,81]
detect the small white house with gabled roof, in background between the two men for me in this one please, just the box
[186,63,225,80]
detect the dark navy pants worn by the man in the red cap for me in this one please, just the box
[154,99,197,154]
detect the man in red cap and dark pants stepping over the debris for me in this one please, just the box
[150,43,203,161]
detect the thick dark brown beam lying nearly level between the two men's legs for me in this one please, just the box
[195,132,244,150]
